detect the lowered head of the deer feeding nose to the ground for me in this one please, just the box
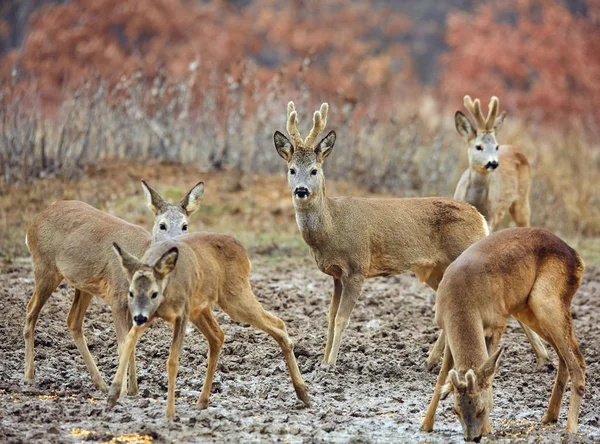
[442,348,503,442]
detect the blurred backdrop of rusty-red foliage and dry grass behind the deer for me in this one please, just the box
[0,0,600,234]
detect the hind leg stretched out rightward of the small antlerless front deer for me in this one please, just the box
[219,285,310,405]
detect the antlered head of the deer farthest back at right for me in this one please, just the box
[454,96,506,174]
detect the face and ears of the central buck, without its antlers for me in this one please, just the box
[274,131,336,205]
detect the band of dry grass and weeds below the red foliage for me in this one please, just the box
[0,74,600,256]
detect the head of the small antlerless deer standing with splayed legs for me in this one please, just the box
[113,243,179,325]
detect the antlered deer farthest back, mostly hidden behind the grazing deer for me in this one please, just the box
[454,95,548,367]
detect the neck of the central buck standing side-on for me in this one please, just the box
[294,186,333,249]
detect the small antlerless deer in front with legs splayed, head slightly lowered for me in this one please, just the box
[108,233,309,418]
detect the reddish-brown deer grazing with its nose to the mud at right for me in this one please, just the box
[422,228,585,442]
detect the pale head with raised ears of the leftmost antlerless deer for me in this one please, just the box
[142,180,204,242]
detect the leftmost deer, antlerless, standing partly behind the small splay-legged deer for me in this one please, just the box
[23,181,204,394]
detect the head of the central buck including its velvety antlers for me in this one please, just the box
[273,102,335,205]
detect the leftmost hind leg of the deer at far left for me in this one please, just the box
[23,267,62,384]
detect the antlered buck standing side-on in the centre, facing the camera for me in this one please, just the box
[274,102,488,364]
